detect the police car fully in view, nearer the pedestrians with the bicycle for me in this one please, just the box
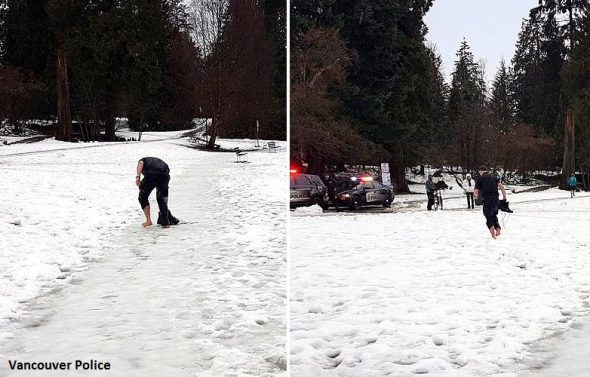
[332,177,395,209]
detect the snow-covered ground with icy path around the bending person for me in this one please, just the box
[0,133,288,377]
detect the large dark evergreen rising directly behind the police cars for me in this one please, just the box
[327,0,435,192]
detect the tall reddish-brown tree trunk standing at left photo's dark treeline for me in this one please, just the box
[55,49,72,141]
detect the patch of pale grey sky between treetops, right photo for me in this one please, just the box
[425,0,538,82]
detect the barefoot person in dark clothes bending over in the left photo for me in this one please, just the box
[135,157,178,228]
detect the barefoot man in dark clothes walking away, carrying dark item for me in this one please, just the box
[474,166,506,239]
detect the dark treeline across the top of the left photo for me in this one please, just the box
[0,0,287,144]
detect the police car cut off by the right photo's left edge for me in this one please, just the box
[289,169,328,209]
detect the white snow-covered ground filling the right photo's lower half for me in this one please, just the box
[289,189,590,377]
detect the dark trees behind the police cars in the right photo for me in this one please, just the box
[291,0,590,191]
